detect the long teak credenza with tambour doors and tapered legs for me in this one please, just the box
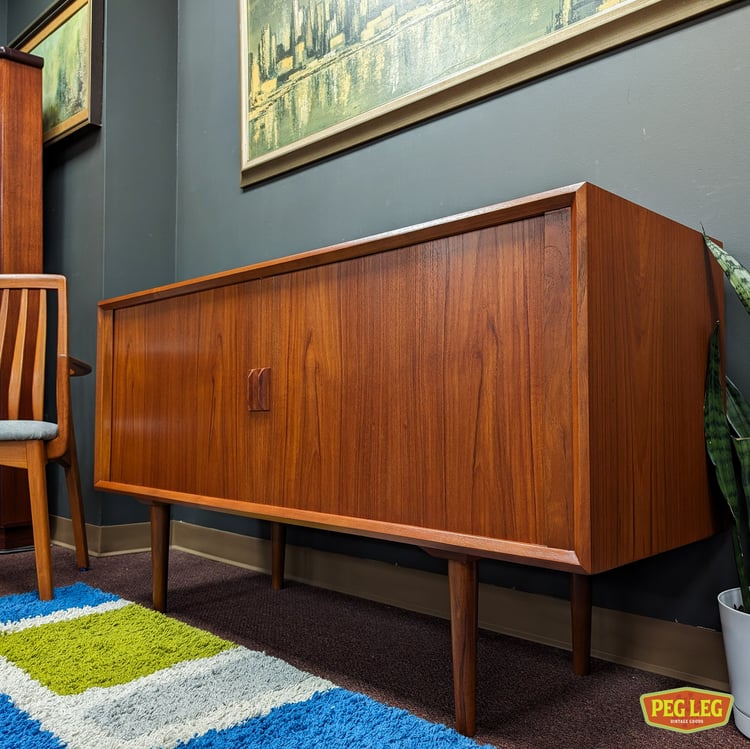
[95,183,724,734]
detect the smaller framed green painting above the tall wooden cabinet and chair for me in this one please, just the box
[12,0,104,144]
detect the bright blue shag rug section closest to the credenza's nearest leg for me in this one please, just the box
[179,688,491,749]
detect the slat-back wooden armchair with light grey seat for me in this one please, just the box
[0,274,89,600]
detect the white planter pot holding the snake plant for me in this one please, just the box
[719,588,750,737]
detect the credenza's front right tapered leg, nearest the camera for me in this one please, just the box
[448,558,478,736]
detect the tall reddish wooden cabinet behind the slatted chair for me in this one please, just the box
[0,47,44,549]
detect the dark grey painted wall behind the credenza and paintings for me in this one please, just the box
[5,0,750,626]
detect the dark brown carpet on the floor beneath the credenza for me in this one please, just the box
[0,547,749,749]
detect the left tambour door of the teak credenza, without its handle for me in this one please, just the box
[107,281,266,499]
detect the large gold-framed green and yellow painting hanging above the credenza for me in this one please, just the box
[239,0,736,186]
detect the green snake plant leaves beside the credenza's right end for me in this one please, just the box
[703,232,750,612]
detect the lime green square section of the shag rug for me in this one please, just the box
[0,604,236,695]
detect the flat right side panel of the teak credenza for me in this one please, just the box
[586,185,723,569]
